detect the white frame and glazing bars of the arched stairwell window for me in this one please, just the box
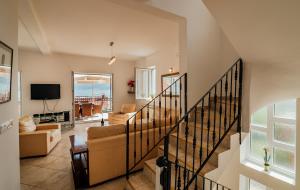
[247,99,297,178]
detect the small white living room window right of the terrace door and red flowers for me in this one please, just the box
[135,67,156,99]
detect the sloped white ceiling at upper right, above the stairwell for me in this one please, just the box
[204,0,300,65]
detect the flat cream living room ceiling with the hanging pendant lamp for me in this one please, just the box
[19,0,179,60]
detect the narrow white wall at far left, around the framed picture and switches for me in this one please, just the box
[0,0,20,190]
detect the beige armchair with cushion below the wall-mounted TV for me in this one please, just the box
[19,116,61,158]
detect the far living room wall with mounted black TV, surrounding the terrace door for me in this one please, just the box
[19,50,134,117]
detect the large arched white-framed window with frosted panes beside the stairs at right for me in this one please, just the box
[249,100,296,177]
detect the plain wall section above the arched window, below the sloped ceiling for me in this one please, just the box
[250,64,300,112]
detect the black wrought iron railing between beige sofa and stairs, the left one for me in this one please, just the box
[126,73,187,179]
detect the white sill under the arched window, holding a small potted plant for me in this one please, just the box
[241,160,295,185]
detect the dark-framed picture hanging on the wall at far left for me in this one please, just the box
[0,41,13,104]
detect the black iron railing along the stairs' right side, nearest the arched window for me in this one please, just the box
[161,59,243,190]
